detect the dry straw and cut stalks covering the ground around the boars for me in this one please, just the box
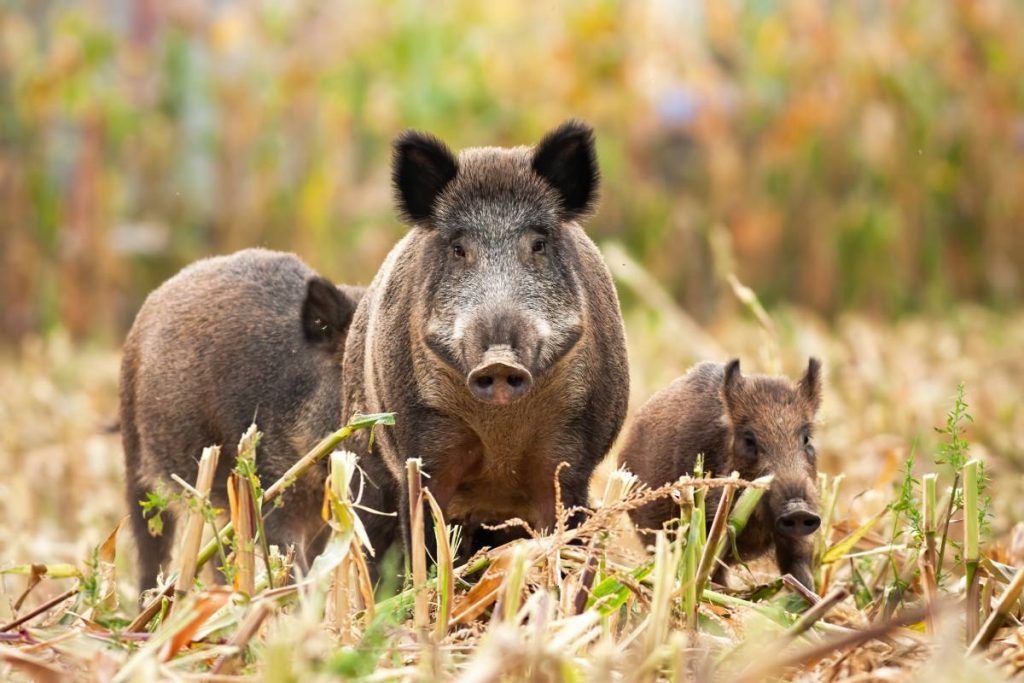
[0,255,1024,681]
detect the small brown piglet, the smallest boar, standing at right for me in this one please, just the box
[620,358,821,589]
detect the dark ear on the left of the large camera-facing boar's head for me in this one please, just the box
[391,130,459,222]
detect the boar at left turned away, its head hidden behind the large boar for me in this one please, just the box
[121,249,361,589]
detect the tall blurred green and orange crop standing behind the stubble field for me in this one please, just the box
[0,0,1024,343]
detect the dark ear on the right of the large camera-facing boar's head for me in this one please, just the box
[532,121,600,220]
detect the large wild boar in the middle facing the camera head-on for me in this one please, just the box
[343,122,629,557]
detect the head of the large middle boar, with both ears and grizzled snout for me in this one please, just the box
[392,122,598,405]
